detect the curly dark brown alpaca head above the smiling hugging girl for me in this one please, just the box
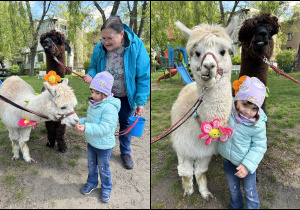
[239,13,280,58]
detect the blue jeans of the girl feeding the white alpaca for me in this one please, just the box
[87,144,113,191]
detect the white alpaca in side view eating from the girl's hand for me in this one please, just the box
[0,76,79,163]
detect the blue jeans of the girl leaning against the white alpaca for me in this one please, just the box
[223,158,259,209]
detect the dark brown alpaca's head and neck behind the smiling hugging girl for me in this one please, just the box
[239,13,280,111]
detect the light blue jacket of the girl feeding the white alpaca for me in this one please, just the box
[79,97,121,149]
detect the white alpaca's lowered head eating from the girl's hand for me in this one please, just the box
[44,79,79,126]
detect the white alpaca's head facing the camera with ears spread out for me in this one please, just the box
[175,17,238,87]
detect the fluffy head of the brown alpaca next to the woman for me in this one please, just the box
[40,29,71,57]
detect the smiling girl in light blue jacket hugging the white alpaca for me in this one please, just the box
[218,77,267,209]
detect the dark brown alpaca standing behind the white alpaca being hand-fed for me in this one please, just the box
[40,29,71,152]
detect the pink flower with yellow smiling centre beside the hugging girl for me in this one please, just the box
[199,119,233,145]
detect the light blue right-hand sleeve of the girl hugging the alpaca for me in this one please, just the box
[242,126,267,174]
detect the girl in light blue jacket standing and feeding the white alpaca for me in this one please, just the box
[75,71,121,202]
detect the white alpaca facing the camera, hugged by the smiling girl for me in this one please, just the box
[171,17,238,200]
